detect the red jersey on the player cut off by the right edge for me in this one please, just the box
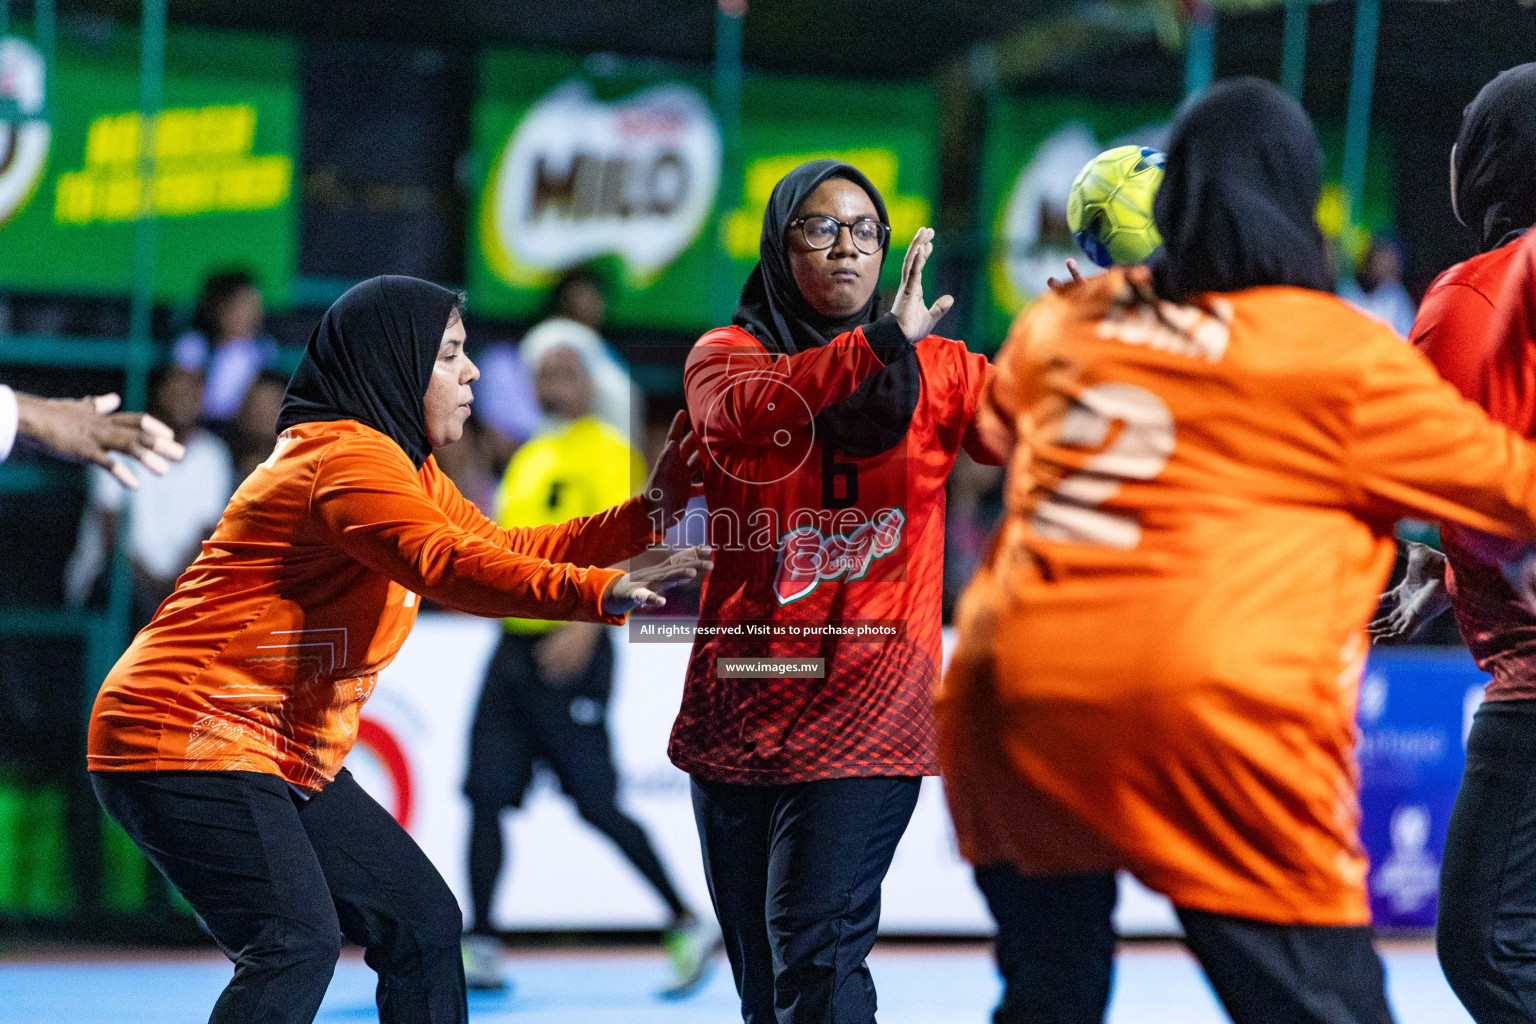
[1412,238,1536,700]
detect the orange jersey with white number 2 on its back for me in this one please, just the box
[938,272,1536,924]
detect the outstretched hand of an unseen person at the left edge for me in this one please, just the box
[15,393,186,490]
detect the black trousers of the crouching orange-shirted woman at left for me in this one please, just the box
[91,769,468,1024]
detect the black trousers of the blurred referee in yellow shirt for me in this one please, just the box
[464,631,688,935]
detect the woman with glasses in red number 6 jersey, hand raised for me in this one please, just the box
[670,160,995,1024]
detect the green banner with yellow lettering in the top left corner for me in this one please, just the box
[0,31,300,306]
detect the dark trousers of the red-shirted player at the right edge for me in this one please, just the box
[1435,700,1536,1024]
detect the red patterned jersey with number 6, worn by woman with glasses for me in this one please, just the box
[668,327,997,785]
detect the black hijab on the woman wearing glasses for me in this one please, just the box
[731,160,922,457]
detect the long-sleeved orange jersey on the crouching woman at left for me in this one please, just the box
[88,421,653,789]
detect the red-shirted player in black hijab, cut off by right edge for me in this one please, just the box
[1384,64,1536,1024]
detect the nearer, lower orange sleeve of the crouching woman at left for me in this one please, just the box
[310,438,624,625]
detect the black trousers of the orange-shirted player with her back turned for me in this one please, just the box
[975,864,1392,1024]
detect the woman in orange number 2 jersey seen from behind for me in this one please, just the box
[938,78,1536,1024]
